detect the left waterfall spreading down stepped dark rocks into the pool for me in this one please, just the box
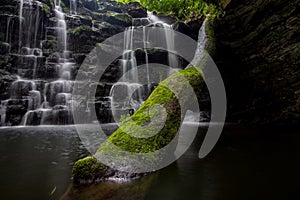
[1,0,76,125]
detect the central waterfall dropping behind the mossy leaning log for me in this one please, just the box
[110,14,179,121]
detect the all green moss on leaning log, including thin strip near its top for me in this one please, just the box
[73,16,215,182]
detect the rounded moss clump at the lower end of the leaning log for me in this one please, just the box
[72,157,107,182]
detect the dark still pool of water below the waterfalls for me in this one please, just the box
[0,125,300,200]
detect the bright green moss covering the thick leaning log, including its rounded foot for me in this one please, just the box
[73,67,203,180]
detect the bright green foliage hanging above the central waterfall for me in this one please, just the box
[118,0,219,21]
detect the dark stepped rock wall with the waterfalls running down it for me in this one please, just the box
[0,0,203,126]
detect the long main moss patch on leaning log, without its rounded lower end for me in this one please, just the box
[97,67,202,153]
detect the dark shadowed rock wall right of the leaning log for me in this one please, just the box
[215,0,300,123]
